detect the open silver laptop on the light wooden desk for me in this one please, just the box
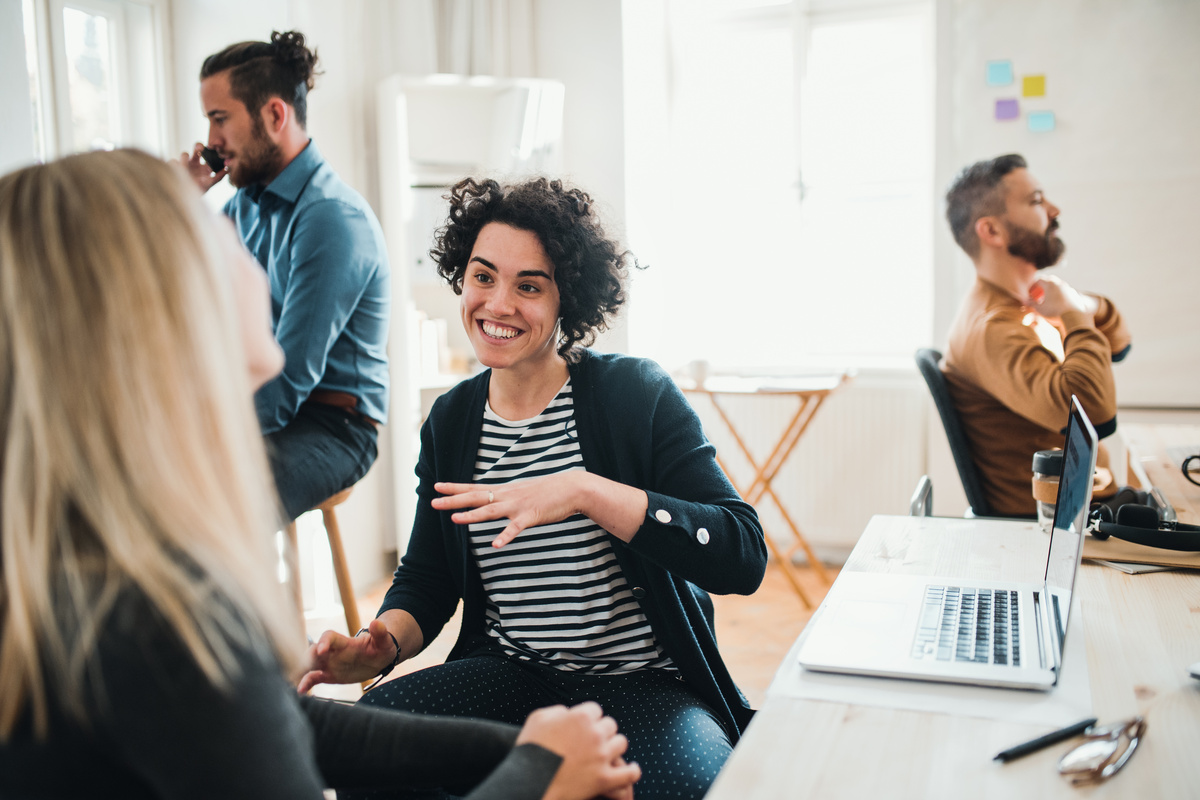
[799,396,1097,690]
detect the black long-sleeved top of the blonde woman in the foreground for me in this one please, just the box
[0,582,560,800]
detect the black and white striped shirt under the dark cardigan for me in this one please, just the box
[469,380,674,674]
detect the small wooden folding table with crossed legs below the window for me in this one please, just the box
[682,372,850,608]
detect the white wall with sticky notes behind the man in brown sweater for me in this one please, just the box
[936,0,1200,407]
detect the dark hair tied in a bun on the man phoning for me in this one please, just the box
[200,30,320,127]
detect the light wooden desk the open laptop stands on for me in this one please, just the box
[708,517,1200,800]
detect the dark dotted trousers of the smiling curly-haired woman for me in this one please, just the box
[350,646,733,800]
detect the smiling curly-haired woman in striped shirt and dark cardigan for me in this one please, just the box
[301,179,767,800]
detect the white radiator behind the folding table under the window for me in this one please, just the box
[688,369,936,564]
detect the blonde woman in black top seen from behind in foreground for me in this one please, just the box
[0,151,637,799]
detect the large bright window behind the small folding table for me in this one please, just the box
[625,0,935,371]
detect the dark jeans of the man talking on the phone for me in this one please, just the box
[265,403,379,522]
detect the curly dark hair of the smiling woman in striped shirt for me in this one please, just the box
[430,178,640,361]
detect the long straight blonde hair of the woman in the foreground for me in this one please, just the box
[0,150,302,741]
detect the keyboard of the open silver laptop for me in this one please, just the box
[912,587,1021,667]
